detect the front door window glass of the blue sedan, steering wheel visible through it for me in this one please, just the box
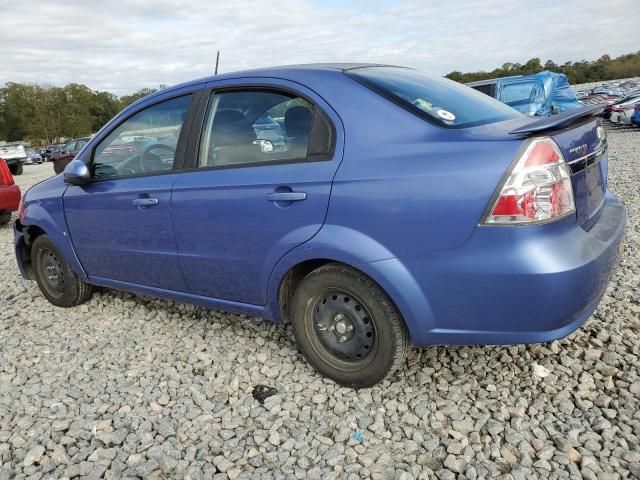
[92,95,191,178]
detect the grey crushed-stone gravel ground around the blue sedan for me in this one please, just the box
[0,130,640,480]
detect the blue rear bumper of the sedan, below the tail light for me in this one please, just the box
[368,193,626,346]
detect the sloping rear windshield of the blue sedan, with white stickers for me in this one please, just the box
[345,67,522,128]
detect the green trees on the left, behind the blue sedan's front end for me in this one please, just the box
[0,82,165,145]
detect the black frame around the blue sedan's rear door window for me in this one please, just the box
[182,83,337,173]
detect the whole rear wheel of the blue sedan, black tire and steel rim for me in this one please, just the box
[291,263,409,388]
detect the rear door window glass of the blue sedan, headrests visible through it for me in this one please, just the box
[198,90,315,167]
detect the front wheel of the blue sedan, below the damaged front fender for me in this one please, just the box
[31,234,93,308]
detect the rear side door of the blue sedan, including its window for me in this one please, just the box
[173,80,343,305]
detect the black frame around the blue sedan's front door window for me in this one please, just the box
[87,88,203,183]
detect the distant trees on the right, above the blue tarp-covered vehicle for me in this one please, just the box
[446,51,640,85]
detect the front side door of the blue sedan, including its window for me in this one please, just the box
[63,93,200,291]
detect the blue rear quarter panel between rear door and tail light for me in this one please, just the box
[296,71,521,261]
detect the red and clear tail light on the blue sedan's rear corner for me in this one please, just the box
[482,137,575,225]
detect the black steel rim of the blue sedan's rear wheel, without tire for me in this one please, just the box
[307,288,378,371]
